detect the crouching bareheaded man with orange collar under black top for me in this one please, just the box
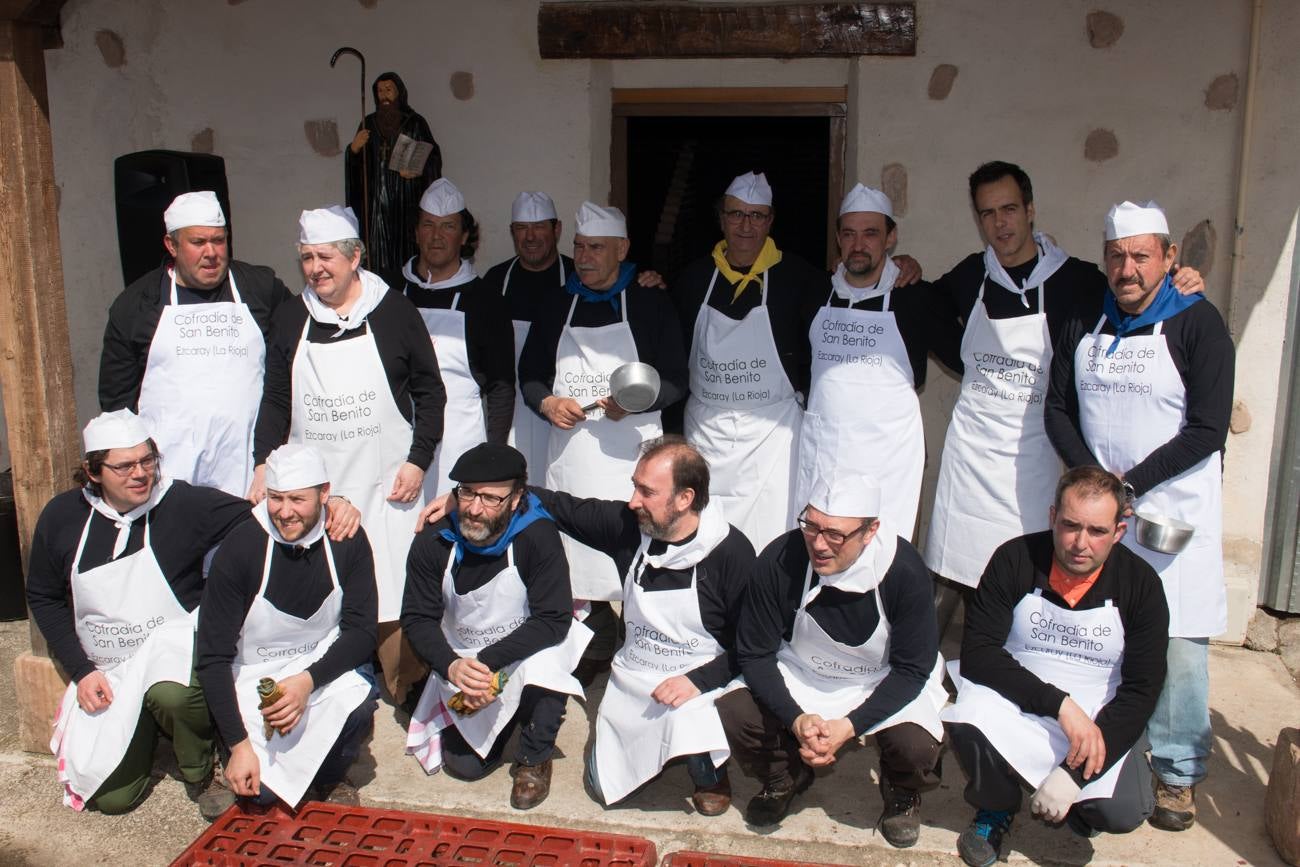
[943,467,1169,867]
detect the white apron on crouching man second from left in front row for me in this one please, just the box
[231,536,371,806]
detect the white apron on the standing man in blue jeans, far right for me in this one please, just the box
[1074,316,1227,638]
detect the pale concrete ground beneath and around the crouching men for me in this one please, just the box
[0,623,1300,867]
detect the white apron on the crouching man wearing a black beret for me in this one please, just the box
[407,545,592,770]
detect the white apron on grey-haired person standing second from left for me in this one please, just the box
[289,316,424,623]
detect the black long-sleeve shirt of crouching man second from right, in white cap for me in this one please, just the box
[736,530,939,734]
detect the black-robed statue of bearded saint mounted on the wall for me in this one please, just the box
[343,73,442,273]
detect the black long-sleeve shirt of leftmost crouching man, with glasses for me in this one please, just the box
[27,486,252,680]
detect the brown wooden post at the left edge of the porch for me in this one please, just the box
[0,19,81,751]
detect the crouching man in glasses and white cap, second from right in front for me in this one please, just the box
[718,473,946,848]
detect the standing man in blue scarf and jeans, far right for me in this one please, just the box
[1044,201,1235,831]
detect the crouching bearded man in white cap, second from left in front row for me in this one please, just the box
[198,443,380,807]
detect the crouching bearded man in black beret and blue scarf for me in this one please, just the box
[402,443,592,810]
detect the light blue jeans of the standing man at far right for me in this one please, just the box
[1147,638,1212,786]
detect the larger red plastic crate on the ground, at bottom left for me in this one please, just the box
[172,801,657,867]
